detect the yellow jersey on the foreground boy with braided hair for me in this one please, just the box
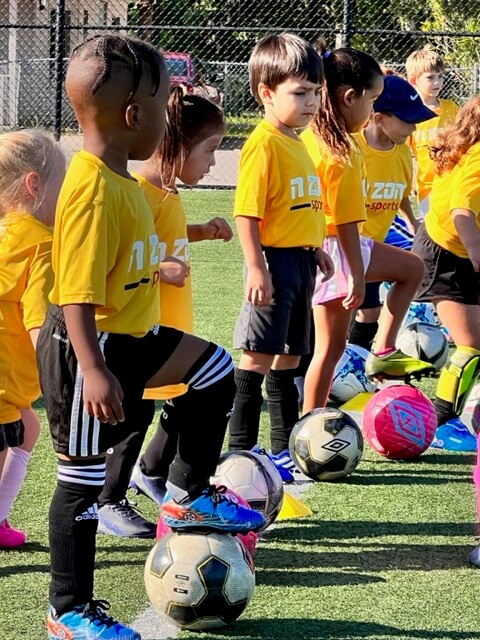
[50,151,160,336]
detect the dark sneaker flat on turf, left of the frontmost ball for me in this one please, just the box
[97,498,157,538]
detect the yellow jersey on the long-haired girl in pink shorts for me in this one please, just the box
[300,127,366,236]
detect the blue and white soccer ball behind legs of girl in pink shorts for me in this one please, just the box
[330,343,376,404]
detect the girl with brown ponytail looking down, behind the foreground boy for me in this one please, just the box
[98,86,233,538]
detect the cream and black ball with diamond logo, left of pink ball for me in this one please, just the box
[289,408,363,481]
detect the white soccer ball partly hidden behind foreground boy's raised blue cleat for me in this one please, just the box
[210,451,284,529]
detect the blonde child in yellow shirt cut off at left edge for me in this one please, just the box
[0,129,65,549]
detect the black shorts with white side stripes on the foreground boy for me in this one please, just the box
[37,305,183,457]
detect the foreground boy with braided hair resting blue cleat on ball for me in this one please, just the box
[37,34,265,640]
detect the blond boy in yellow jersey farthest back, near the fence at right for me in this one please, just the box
[405,46,458,218]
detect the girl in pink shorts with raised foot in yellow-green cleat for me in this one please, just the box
[302,44,433,412]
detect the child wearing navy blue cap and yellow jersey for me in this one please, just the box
[349,75,435,350]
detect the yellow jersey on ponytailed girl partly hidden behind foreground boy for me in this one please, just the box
[133,173,193,400]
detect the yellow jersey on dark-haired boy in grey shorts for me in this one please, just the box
[234,120,325,247]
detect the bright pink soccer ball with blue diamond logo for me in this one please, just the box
[363,384,437,459]
